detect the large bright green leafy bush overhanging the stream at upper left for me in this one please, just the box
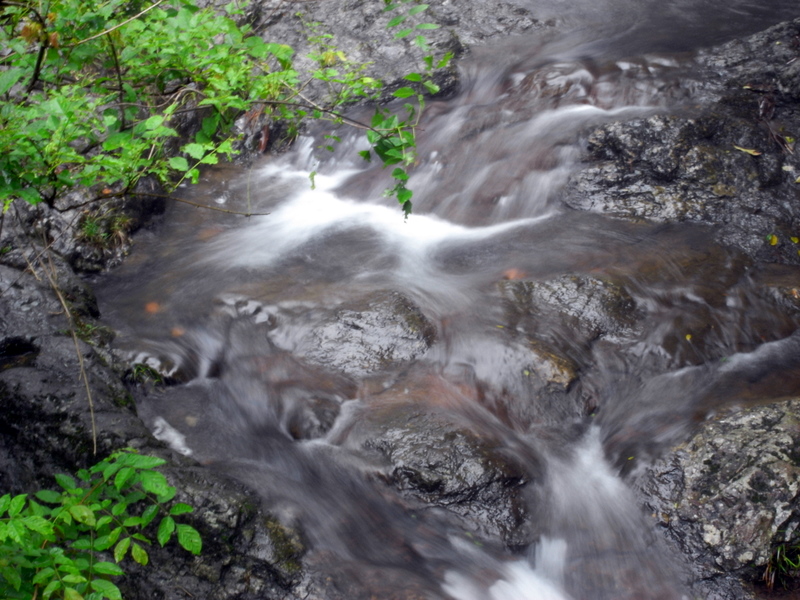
[0,0,452,213]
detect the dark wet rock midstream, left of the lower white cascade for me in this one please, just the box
[351,382,533,544]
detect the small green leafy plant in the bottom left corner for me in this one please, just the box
[0,449,202,600]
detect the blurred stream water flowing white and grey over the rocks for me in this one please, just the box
[98,0,798,600]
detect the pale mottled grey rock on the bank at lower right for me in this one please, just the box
[639,401,800,598]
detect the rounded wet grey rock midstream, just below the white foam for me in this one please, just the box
[296,292,436,378]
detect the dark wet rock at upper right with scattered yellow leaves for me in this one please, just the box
[564,21,800,264]
